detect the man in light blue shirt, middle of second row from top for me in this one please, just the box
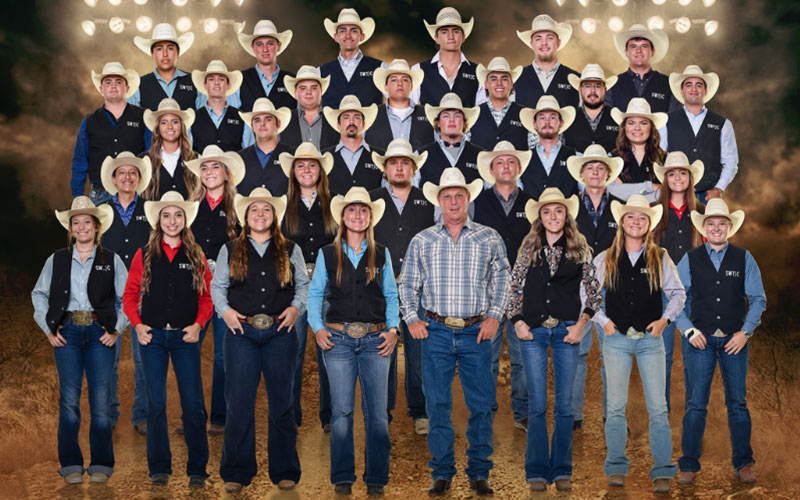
[364,59,433,151]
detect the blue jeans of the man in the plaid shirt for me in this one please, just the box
[422,320,496,481]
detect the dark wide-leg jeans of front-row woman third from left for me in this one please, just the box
[219,323,300,486]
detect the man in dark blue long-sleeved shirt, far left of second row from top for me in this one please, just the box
[70,62,151,205]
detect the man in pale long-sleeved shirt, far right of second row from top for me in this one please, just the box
[659,64,739,203]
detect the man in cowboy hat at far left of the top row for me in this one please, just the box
[128,23,198,111]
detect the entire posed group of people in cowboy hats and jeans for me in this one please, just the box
[32,3,766,495]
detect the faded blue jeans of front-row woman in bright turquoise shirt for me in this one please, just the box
[323,332,392,486]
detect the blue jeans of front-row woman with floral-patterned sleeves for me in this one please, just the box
[520,321,578,483]
